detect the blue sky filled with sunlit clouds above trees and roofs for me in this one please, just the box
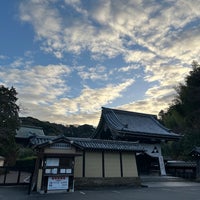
[0,0,200,126]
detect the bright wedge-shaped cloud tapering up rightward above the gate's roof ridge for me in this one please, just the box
[49,77,134,116]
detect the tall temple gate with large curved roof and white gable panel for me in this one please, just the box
[93,108,180,175]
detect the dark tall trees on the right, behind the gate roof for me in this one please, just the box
[159,61,200,159]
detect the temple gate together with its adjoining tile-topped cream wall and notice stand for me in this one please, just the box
[17,108,180,193]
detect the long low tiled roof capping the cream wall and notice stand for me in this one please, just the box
[30,136,143,152]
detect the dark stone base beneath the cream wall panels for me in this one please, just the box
[74,177,141,189]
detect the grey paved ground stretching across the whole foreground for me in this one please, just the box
[0,177,200,200]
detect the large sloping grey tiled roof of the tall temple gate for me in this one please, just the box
[96,108,179,138]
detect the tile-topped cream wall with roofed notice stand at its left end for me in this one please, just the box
[31,136,143,193]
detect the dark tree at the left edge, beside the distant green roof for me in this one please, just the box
[0,85,20,165]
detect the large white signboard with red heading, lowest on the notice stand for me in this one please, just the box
[47,176,69,190]
